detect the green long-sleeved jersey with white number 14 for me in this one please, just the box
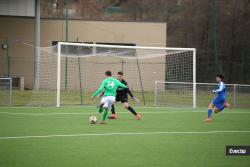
[93,77,127,97]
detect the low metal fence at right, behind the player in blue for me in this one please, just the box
[154,81,250,108]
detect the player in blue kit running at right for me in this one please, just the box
[204,74,230,122]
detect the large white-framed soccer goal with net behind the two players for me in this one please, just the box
[31,42,196,107]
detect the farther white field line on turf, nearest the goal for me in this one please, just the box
[0,111,250,116]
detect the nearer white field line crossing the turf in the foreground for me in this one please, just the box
[0,131,250,140]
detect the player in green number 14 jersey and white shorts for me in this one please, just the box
[92,71,127,124]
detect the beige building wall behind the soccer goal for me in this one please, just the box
[0,17,166,90]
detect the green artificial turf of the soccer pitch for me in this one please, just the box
[0,104,250,167]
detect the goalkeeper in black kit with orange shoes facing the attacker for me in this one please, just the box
[100,71,141,120]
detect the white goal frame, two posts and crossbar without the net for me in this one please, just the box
[56,42,196,108]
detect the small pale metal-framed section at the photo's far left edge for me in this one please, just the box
[0,78,12,106]
